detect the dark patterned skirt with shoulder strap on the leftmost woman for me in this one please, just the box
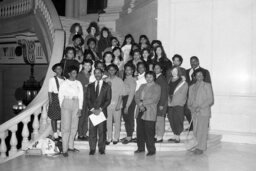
[48,93,61,120]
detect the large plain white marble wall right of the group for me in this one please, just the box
[157,0,256,142]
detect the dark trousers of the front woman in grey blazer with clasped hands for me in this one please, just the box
[136,113,156,152]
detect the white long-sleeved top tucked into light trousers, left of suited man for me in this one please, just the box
[59,80,84,109]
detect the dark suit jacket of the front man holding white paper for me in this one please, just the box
[87,81,112,117]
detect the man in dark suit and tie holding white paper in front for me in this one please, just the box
[87,68,111,155]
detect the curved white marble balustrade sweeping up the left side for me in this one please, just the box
[0,0,65,163]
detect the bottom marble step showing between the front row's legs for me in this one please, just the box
[75,134,222,151]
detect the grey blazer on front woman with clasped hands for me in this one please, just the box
[135,83,161,121]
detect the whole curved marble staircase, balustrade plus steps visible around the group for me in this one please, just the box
[0,0,221,163]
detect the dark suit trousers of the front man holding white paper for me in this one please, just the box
[89,121,107,150]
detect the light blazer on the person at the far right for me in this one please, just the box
[188,82,214,117]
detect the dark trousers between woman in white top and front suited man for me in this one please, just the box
[78,108,89,137]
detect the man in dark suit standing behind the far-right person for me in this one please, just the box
[184,56,211,130]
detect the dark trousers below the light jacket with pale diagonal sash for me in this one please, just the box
[168,106,184,135]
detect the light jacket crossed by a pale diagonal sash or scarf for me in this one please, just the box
[168,81,188,107]
